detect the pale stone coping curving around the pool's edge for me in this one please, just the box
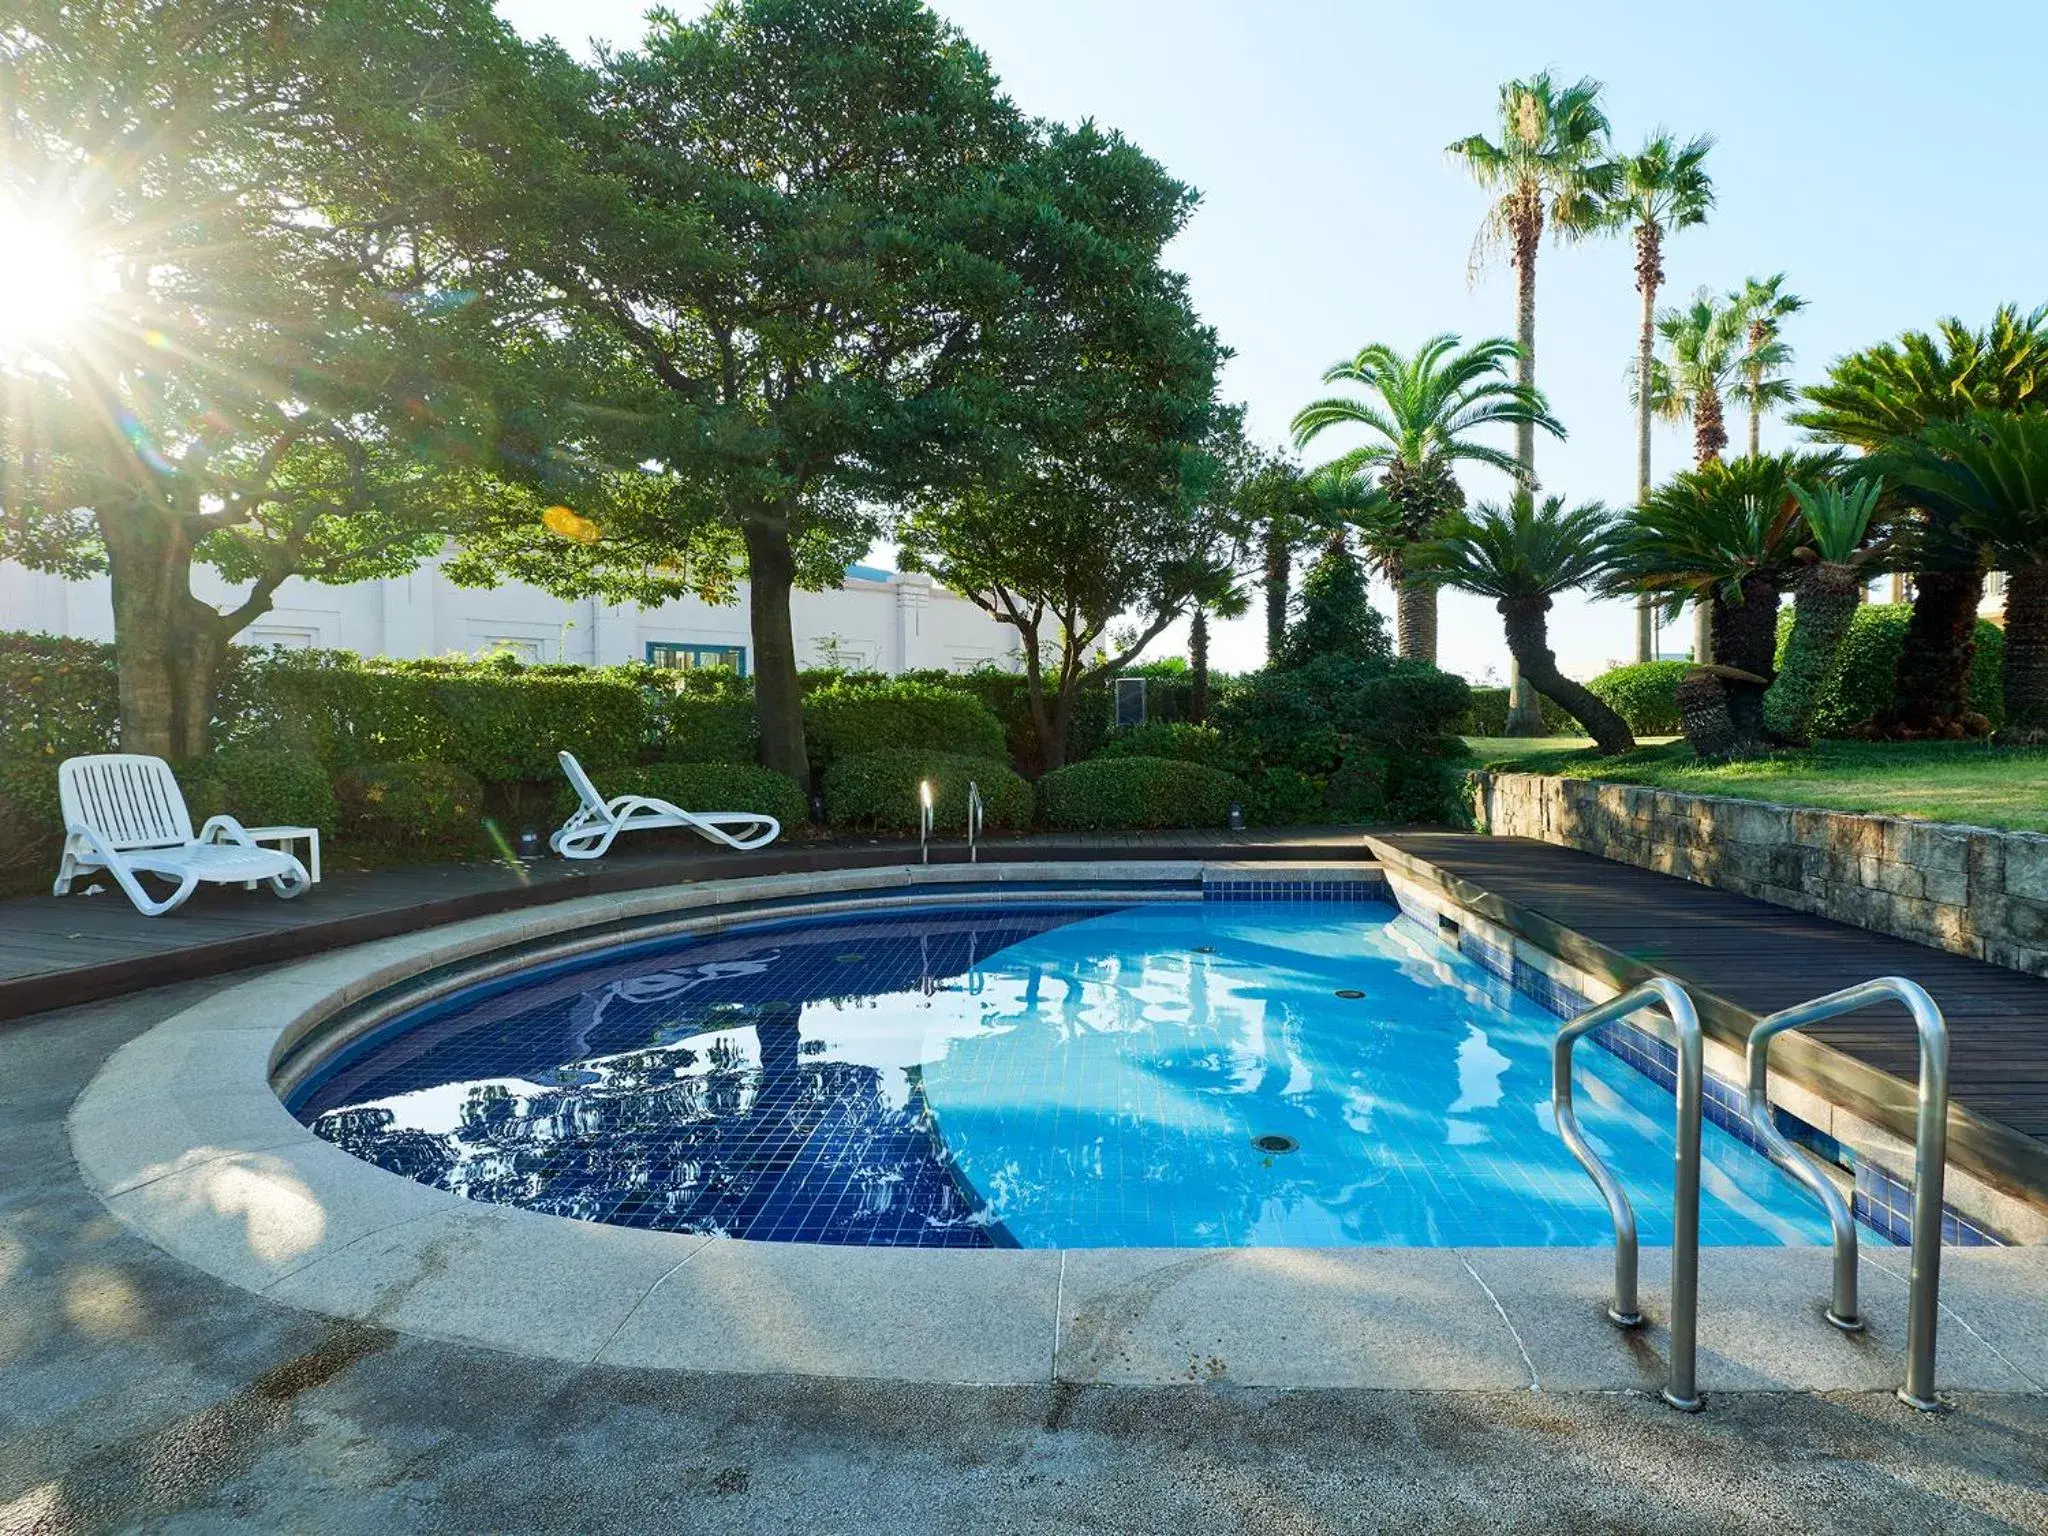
[56,864,2048,1393]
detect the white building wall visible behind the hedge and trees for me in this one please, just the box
[0,561,1022,672]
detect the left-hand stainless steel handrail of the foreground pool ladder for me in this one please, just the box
[1550,977,1704,1413]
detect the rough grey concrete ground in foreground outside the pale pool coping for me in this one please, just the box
[12,983,2048,1536]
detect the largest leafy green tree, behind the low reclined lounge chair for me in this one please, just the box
[454,0,1081,782]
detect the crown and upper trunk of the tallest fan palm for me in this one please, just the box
[1448,70,1614,485]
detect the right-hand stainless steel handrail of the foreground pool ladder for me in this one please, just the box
[1747,977,1948,1411]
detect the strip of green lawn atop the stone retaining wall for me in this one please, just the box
[1466,737,2048,831]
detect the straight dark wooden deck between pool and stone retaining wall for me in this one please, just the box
[1374,831,2048,1188]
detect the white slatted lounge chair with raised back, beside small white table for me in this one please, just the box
[55,752,313,918]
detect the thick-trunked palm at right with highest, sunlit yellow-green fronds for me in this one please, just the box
[1792,305,2048,737]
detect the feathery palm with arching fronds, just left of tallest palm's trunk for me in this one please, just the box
[1294,332,1565,662]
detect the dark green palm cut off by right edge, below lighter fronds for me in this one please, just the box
[1876,408,2048,745]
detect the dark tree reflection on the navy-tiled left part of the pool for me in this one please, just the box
[313,1001,991,1247]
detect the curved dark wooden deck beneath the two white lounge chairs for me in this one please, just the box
[0,827,1368,1020]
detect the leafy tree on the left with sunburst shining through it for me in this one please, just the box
[0,0,520,758]
